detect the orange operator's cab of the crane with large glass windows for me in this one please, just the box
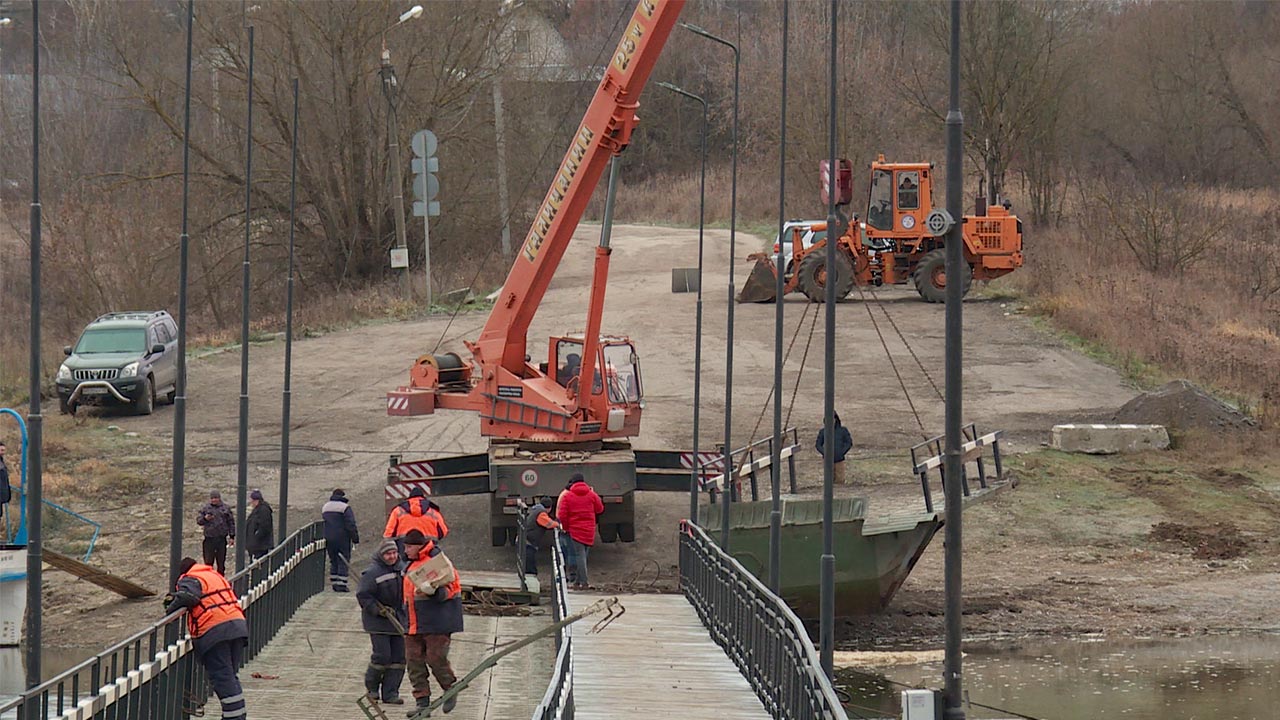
[547,334,644,437]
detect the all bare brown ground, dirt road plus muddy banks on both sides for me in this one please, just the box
[30,225,1280,647]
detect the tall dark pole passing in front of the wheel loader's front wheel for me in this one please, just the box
[819,0,840,678]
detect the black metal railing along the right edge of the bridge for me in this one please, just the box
[680,521,847,720]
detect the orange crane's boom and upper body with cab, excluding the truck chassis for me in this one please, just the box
[387,0,685,445]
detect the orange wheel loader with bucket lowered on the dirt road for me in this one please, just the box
[737,155,1023,302]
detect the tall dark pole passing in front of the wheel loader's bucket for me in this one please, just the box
[769,3,791,594]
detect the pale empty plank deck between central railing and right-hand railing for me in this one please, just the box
[570,593,769,720]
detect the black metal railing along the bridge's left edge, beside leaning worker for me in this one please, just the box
[0,523,325,720]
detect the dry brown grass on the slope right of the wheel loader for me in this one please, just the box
[1010,206,1280,415]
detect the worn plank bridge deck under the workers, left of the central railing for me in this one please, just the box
[220,591,556,720]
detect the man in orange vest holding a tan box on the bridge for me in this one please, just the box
[403,530,462,716]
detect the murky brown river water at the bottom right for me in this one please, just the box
[842,634,1280,720]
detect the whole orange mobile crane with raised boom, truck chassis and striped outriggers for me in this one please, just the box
[385,0,689,546]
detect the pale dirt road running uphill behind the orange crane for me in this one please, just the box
[47,225,1162,645]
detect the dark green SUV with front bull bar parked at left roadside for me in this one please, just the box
[58,310,178,415]
